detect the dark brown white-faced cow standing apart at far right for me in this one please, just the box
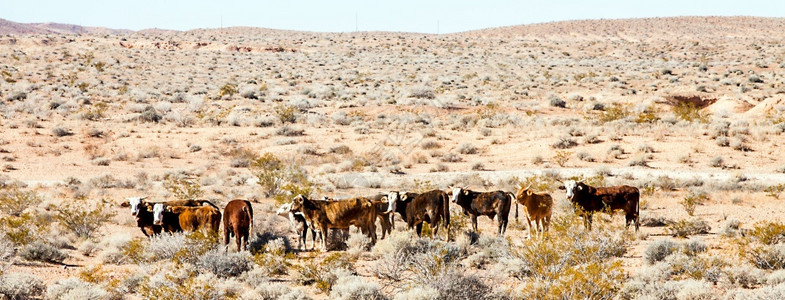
[564,180,640,231]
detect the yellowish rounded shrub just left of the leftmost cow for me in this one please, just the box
[55,200,115,238]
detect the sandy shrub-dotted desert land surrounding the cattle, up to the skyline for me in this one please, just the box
[0,17,785,299]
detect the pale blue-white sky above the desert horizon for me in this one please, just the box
[0,0,785,33]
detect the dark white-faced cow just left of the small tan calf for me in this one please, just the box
[451,188,515,235]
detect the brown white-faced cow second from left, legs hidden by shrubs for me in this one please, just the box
[153,203,221,234]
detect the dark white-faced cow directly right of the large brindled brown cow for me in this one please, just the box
[387,190,450,240]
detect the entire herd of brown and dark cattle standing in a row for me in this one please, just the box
[123,180,640,251]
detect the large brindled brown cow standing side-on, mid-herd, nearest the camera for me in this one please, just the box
[291,195,376,251]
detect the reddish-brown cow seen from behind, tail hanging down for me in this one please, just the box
[223,199,253,252]
